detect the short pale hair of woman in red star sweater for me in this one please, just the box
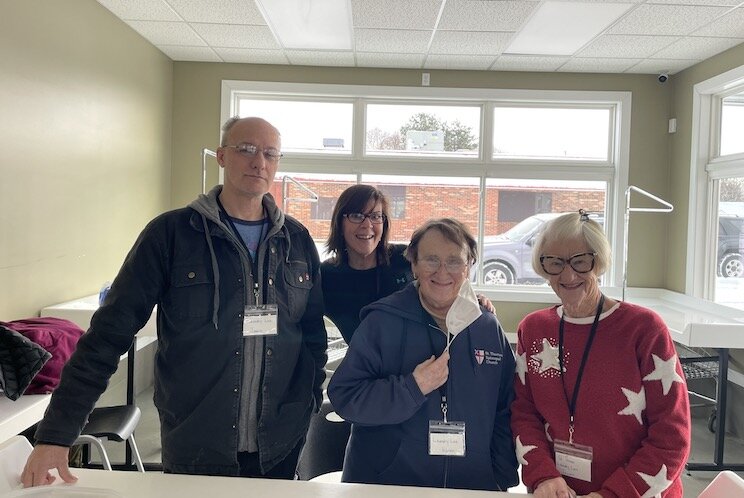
[532,210,612,279]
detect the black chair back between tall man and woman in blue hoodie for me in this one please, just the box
[297,400,351,481]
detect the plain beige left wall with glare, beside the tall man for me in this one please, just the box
[0,0,173,320]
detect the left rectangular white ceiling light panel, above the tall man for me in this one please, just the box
[256,0,351,50]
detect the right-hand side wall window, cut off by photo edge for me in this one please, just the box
[687,66,744,309]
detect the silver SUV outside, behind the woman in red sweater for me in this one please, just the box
[481,213,604,285]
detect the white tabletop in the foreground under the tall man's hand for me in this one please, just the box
[7,469,531,498]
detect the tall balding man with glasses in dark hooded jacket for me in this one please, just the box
[22,118,327,487]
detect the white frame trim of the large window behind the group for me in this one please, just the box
[220,80,632,294]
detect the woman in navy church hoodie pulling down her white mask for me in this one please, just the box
[328,218,518,490]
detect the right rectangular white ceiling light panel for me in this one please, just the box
[504,1,633,55]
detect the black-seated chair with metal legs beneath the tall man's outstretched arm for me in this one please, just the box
[75,405,145,472]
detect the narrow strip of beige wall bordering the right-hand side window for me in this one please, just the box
[667,44,744,292]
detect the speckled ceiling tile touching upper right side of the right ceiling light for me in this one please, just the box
[607,4,728,35]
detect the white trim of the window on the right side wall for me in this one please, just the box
[685,66,744,299]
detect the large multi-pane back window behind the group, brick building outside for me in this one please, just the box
[222,81,630,299]
